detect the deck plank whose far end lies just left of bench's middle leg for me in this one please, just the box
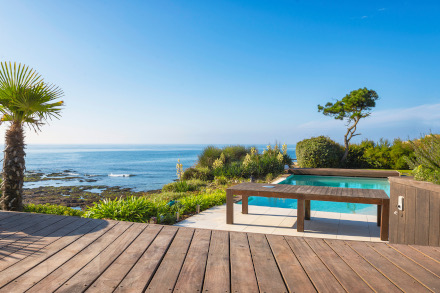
[266,235,316,292]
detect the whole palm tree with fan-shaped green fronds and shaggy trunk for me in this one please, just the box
[0,62,63,211]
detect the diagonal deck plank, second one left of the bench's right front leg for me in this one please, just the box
[324,239,401,293]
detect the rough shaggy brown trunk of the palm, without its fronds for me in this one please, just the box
[1,122,26,211]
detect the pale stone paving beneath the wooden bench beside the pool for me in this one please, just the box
[176,204,381,242]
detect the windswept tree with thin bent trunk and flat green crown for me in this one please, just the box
[318,88,379,164]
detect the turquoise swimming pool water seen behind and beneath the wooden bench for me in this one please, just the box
[241,175,390,215]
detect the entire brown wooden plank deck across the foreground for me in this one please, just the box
[0,212,440,292]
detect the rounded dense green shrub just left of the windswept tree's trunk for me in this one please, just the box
[296,136,344,168]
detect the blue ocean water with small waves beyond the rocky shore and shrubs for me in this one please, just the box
[24,145,296,191]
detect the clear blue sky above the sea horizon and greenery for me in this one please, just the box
[0,0,440,144]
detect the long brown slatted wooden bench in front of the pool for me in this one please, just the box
[226,183,390,241]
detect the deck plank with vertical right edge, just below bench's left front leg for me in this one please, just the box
[202,230,231,293]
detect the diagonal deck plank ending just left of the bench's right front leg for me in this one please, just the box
[346,241,429,292]
